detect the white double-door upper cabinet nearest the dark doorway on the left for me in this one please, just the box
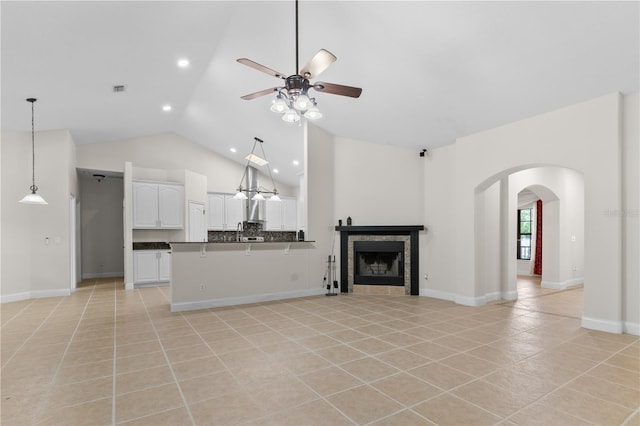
[133,182,184,229]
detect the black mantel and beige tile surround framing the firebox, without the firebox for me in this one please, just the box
[336,225,424,295]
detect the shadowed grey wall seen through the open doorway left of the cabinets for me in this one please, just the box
[78,175,124,279]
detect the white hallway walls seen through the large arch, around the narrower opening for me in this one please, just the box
[474,166,584,316]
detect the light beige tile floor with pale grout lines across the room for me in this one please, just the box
[0,280,640,426]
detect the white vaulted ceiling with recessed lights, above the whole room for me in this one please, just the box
[0,0,640,184]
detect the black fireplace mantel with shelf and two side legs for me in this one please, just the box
[336,225,424,296]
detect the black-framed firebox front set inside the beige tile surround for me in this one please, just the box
[353,241,404,286]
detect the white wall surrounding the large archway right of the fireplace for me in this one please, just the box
[426,93,638,332]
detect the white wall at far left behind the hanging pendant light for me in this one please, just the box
[0,130,77,302]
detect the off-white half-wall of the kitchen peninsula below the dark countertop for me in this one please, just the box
[170,241,324,312]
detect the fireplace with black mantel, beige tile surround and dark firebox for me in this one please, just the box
[336,225,424,295]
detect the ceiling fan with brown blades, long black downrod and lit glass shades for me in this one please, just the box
[237,0,362,123]
